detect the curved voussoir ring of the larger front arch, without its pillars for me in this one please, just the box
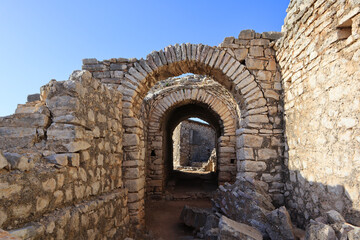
[123,43,268,123]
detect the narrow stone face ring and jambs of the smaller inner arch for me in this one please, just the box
[146,85,240,193]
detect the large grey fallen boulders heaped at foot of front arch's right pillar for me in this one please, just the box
[181,177,296,240]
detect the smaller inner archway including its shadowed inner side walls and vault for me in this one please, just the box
[143,76,240,196]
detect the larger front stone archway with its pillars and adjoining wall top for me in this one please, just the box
[84,39,282,224]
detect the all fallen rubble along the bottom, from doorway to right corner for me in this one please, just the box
[180,177,360,240]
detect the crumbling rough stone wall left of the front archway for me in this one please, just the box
[0,71,129,239]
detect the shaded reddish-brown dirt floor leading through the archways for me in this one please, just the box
[145,172,217,240]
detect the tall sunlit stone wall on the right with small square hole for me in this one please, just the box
[276,0,360,225]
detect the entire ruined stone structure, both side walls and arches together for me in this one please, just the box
[0,0,360,239]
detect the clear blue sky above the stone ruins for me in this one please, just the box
[0,0,289,116]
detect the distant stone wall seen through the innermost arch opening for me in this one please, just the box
[173,120,217,167]
